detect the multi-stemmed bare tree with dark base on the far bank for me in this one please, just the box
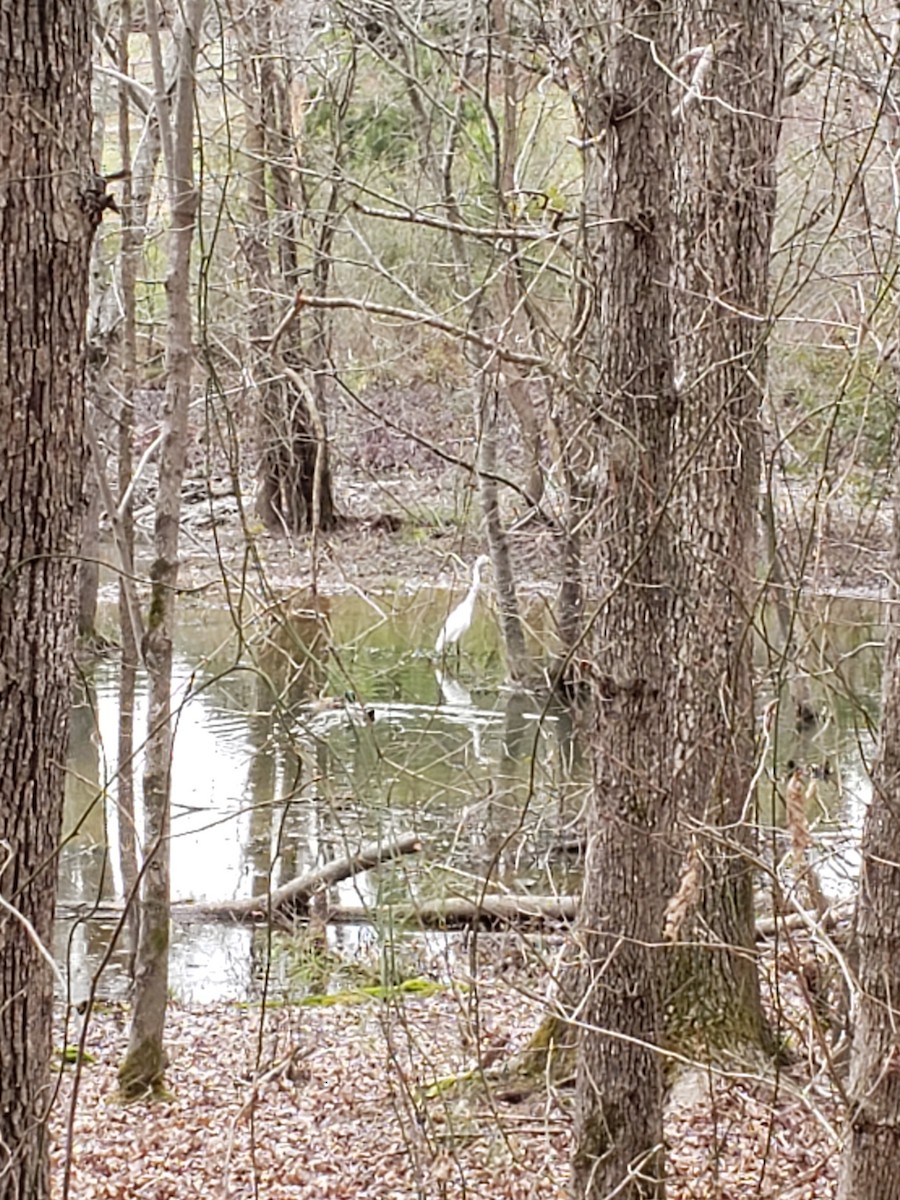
[238,0,336,534]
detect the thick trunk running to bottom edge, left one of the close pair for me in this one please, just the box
[574,0,677,1200]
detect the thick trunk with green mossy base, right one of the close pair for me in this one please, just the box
[667,0,782,1050]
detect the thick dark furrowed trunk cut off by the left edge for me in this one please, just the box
[0,0,97,1200]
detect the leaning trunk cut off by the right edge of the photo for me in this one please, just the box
[838,417,900,1200]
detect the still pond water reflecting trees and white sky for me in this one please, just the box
[61,590,881,1002]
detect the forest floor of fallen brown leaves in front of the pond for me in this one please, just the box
[50,931,840,1200]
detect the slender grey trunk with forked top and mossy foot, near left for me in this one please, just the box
[119,0,203,1099]
